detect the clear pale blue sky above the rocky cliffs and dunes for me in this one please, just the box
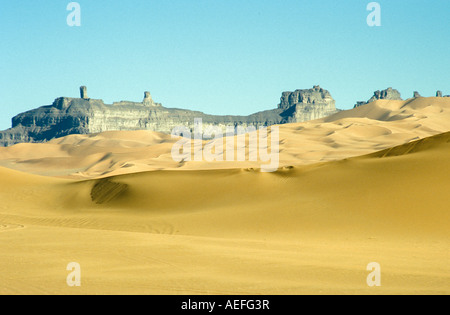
[0,0,450,129]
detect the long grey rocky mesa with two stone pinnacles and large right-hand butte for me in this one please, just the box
[0,86,337,146]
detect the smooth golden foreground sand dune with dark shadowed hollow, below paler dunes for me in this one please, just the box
[0,127,450,294]
